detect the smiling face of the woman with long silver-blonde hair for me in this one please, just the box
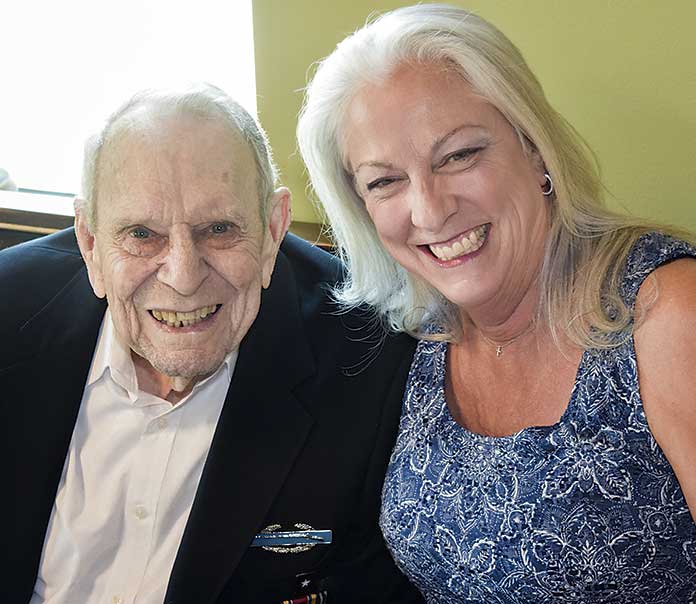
[343,64,548,320]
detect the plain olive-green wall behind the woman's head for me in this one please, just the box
[254,0,696,230]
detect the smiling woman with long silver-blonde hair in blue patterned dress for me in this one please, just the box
[298,5,696,604]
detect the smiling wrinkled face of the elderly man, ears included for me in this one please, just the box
[77,115,289,379]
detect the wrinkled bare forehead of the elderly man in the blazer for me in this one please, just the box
[98,108,259,217]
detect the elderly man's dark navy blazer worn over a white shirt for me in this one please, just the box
[0,229,422,604]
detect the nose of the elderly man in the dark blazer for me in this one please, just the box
[157,229,210,296]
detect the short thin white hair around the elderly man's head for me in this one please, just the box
[80,83,278,230]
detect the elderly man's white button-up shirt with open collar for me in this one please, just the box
[31,309,237,604]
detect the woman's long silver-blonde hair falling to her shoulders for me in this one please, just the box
[297,4,684,348]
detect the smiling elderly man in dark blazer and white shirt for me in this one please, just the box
[0,86,419,604]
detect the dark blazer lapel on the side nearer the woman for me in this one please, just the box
[165,256,314,604]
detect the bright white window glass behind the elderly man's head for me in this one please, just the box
[0,0,256,193]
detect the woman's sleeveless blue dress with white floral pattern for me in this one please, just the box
[381,233,696,604]
